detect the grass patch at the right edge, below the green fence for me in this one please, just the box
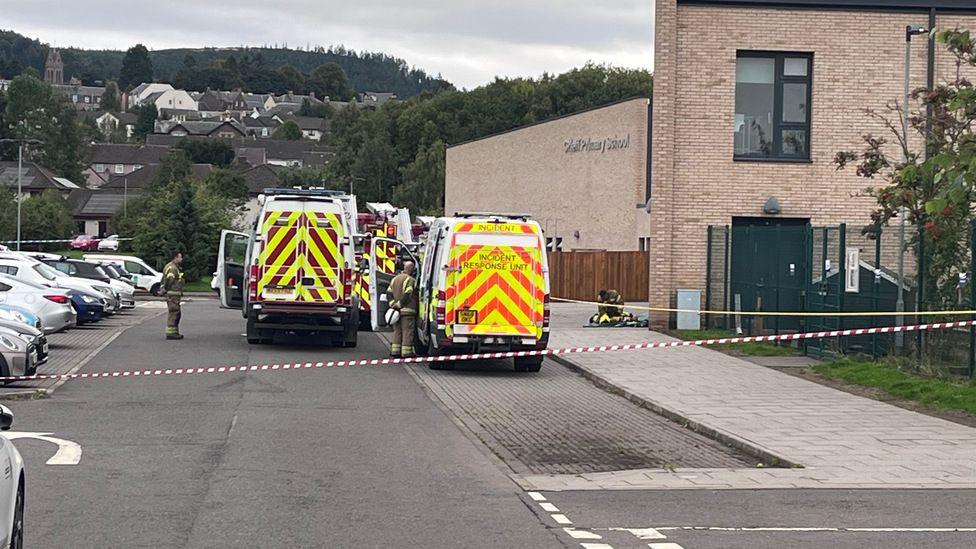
[813,358,976,415]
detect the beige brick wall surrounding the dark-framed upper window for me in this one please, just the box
[650,0,976,321]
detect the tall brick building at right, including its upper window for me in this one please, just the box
[650,0,976,324]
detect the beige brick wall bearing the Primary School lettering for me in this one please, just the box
[444,99,651,250]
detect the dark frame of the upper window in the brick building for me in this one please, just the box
[732,50,814,164]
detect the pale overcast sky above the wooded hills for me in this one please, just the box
[0,0,654,88]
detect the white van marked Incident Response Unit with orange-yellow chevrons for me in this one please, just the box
[378,213,549,372]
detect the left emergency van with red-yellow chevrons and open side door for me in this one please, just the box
[217,189,359,347]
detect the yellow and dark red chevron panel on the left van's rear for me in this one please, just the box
[258,211,343,303]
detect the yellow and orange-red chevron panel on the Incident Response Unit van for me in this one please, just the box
[445,245,545,338]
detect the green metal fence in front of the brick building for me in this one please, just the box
[705,221,976,376]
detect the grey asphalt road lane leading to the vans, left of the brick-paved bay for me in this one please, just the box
[11,302,563,549]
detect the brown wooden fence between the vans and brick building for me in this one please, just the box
[549,251,650,302]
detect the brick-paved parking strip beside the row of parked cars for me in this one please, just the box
[0,301,166,399]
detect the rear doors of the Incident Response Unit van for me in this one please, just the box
[445,222,547,339]
